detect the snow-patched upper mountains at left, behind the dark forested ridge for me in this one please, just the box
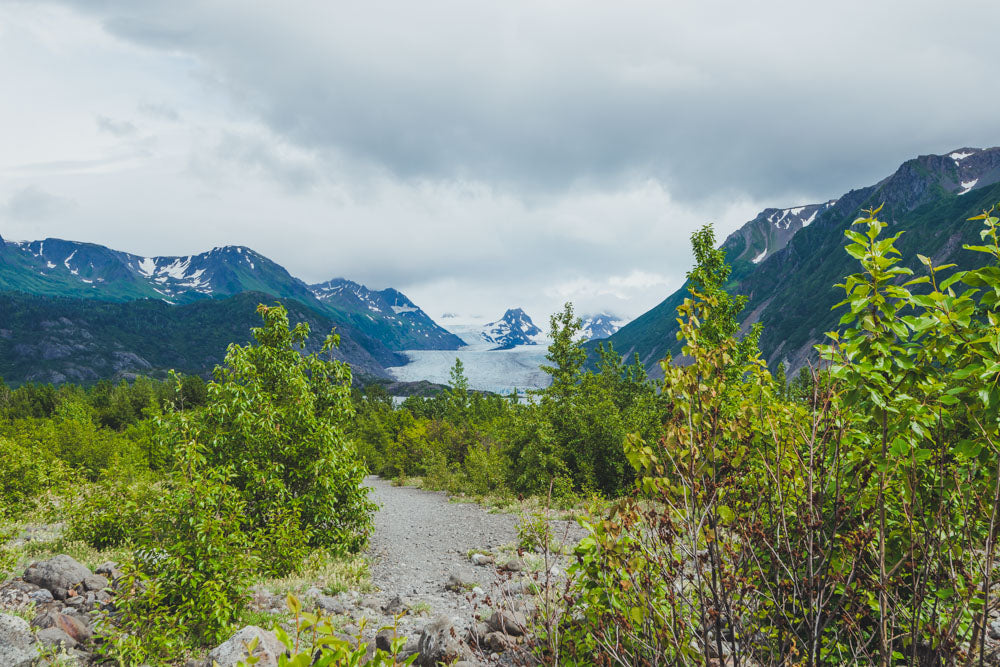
[0,238,462,380]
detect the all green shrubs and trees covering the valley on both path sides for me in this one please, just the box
[0,200,1000,666]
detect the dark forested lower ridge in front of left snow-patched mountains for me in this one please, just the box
[0,292,406,384]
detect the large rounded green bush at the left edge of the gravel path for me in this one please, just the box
[194,305,374,553]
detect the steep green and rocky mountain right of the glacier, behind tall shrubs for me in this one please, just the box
[588,148,1000,376]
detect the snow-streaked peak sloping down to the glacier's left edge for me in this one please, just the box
[309,278,465,350]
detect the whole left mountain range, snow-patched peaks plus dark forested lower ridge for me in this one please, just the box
[0,238,463,383]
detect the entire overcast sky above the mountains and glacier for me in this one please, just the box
[0,0,1000,323]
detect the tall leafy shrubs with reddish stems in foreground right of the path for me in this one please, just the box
[550,206,1000,665]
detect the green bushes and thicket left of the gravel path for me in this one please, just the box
[0,305,373,664]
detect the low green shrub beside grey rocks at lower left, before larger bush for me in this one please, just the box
[103,441,257,664]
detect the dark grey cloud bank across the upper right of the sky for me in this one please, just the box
[58,0,1000,204]
